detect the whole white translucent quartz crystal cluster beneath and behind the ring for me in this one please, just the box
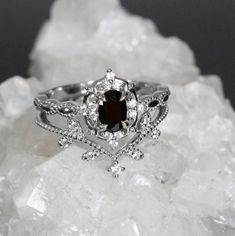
[0,0,235,236]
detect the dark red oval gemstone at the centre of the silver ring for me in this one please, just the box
[98,90,127,132]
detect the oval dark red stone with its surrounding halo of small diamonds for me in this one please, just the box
[84,70,138,147]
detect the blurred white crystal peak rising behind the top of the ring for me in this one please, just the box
[31,0,199,86]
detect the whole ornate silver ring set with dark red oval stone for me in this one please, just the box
[34,69,170,177]
